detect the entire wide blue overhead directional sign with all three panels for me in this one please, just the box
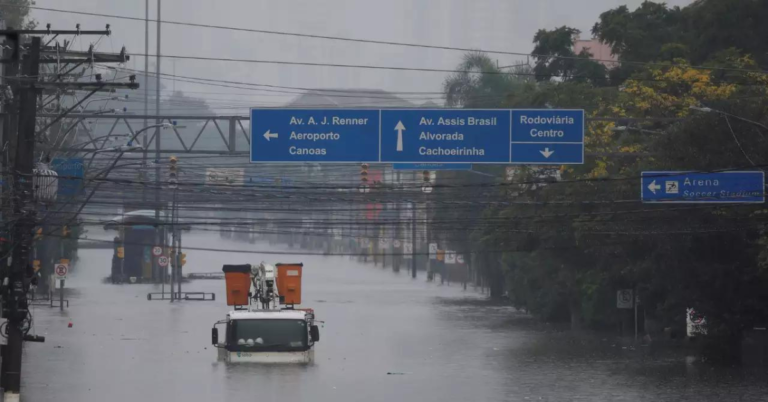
[251,109,584,164]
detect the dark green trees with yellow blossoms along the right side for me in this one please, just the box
[438,0,768,357]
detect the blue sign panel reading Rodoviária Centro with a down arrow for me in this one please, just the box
[510,109,584,165]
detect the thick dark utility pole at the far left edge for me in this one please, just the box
[3,37,41,395]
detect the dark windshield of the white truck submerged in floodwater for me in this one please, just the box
[230,320,307,350]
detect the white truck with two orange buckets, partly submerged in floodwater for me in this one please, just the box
[211,263,320,363]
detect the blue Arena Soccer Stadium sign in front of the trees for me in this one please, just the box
[641,171,765,204]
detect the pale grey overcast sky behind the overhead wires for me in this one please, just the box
[33,0,691,113]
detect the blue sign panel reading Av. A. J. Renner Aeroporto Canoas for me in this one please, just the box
[251,109,379,162]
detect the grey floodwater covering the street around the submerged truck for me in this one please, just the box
[22,232,767,402]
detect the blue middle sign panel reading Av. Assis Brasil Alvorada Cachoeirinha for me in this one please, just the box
[381,109,510,163]
